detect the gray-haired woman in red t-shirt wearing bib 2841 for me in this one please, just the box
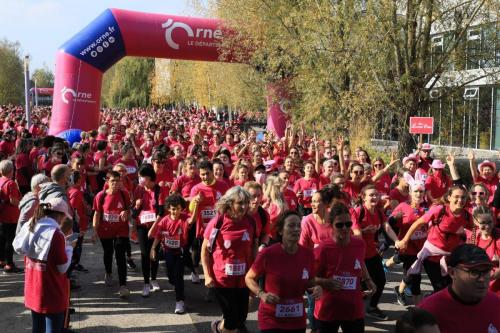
[201,186,256,332]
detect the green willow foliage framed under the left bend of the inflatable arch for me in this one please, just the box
[102,57,154,108]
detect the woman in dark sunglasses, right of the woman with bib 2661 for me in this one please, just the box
[314,202,377,333]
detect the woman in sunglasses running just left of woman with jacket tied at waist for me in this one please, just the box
[385,173,427,306]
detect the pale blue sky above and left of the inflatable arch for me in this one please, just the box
[0,0,199,71]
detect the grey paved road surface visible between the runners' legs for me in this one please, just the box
[0,239,430,333]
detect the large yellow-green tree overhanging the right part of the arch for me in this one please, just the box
[214,0,499,154]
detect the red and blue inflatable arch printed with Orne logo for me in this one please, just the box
[49,9,285,143]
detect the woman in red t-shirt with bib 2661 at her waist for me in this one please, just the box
[245,212,322,333]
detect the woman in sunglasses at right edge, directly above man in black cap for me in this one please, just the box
[467,205,500,295]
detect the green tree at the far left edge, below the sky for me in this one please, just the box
[0,40,24,104]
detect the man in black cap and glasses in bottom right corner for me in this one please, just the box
[419,244,500,333]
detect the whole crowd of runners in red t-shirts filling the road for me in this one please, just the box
[0,106,500,333]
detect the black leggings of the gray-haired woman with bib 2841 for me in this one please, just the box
[214,288,250,330]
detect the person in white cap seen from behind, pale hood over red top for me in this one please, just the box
[13,198,74,332]
